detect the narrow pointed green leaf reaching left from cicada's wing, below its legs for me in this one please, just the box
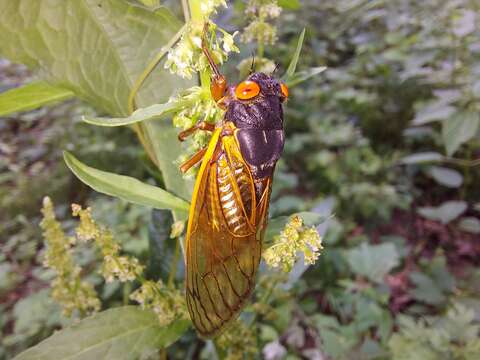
[63,151,190,218]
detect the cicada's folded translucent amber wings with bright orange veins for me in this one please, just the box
[186,128,271,338]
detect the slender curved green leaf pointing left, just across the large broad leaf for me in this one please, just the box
[82,101,191,126]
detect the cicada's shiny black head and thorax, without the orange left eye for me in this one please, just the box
[225,73,284,180]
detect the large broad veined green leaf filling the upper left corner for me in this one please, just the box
[0,0,192,208]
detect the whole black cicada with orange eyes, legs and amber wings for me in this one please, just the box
[179,27,288,338]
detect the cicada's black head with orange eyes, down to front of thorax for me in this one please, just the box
[224,73,288,130]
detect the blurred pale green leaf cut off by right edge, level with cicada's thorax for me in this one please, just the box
[442,112,480,156]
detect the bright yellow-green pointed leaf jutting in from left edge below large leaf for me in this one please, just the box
[0,81,75,116]
